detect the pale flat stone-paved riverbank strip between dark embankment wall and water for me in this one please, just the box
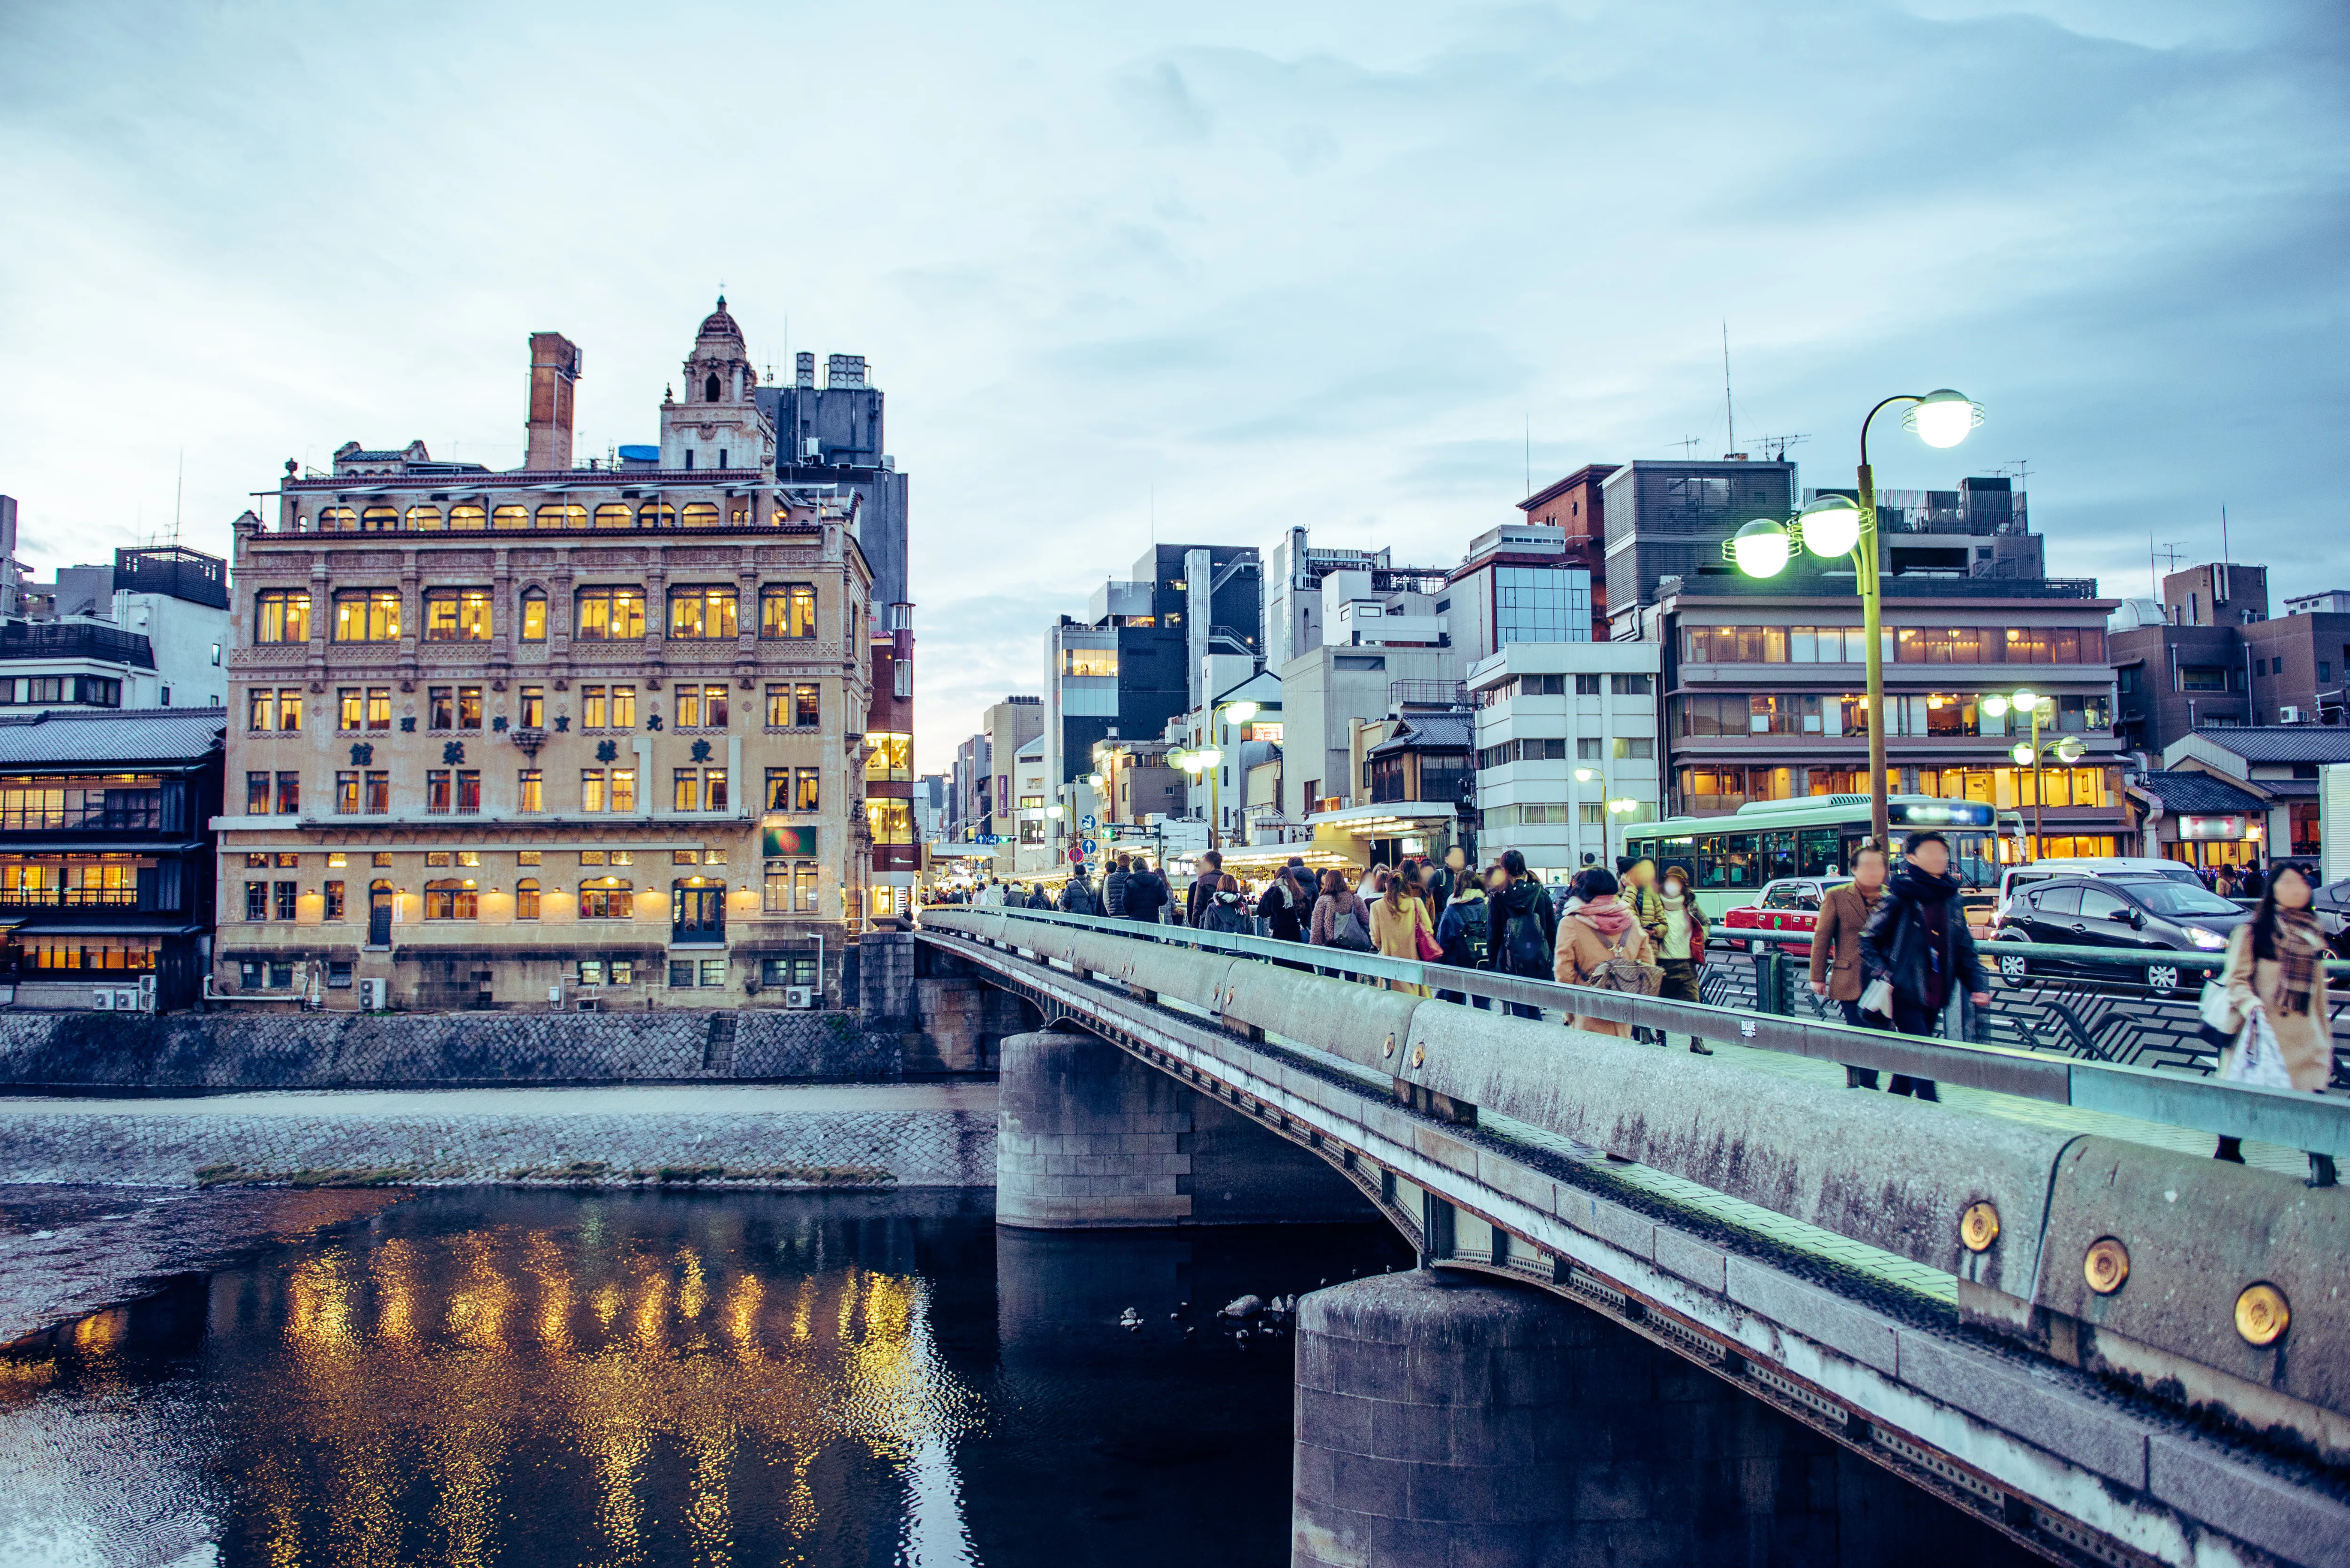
[0,1084,996,1187]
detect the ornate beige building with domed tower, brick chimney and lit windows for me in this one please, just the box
[214,301,886,1006]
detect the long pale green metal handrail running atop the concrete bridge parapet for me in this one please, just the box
[935,907,2350,1161]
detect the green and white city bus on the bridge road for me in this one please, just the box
[1624,795,2023,919]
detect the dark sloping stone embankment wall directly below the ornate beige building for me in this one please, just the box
[0,1008,907,1093]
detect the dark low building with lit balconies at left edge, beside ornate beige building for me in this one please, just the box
[0,708,222,1011]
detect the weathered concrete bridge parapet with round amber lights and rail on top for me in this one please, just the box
[924,910,2350,1561]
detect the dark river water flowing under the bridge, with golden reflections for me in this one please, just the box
[0,1190,2028,1568]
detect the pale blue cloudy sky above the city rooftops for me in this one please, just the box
[0,0,2350,771]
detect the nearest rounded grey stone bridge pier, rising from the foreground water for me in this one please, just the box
[1290,1270,1589,1568]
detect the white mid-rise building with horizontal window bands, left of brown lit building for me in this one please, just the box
[1469,642,1664,879]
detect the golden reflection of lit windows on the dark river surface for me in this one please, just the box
[224,1216,978,1568]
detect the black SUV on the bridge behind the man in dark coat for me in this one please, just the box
[2000,874,2251,992]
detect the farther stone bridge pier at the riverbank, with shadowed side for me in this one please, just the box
[996,1027,1377,1230]
